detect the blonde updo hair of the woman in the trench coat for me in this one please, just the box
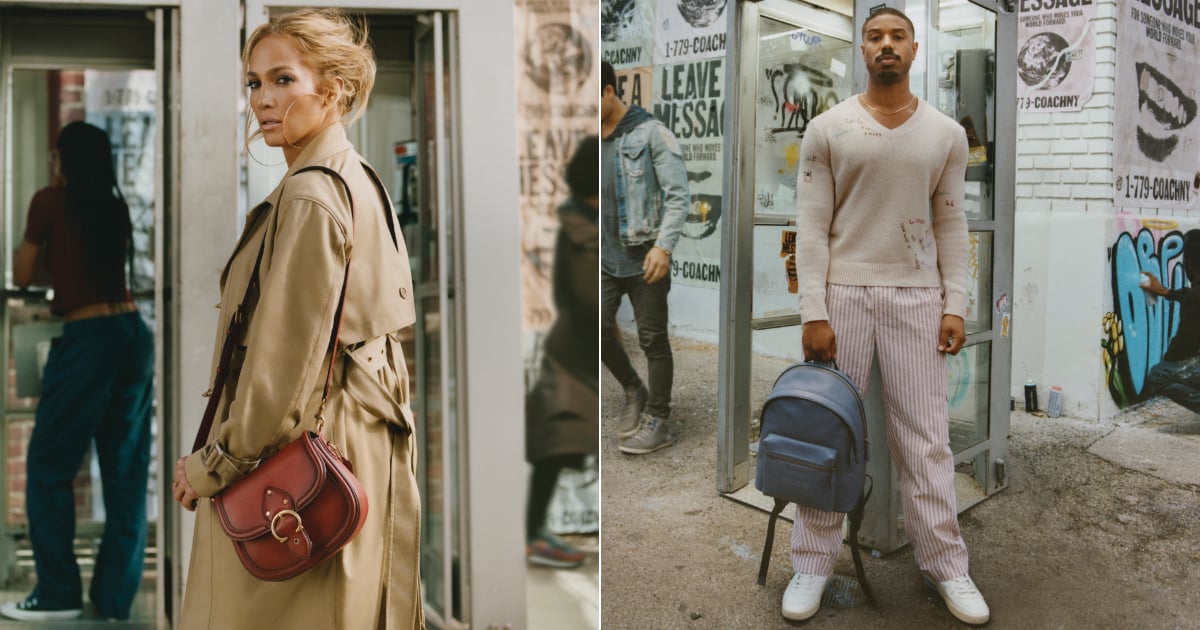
[241,8,376,125]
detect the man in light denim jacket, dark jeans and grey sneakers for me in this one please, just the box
[600,61,691,455]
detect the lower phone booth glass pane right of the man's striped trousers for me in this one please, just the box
[946,343,991,452]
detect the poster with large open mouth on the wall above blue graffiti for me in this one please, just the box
[1112,0,1200,210]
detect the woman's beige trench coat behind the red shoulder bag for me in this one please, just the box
[179,125,425,630]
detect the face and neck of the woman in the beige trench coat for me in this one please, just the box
[246,35,337,164]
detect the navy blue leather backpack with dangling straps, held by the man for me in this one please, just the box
[755,362,875,604]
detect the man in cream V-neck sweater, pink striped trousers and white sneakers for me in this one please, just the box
[782,8,989,624]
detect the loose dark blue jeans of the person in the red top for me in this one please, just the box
[25,312,154,619]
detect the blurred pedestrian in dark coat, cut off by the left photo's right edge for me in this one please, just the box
[526,136,600,569]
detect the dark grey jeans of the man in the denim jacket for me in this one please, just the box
[600,272,674,419]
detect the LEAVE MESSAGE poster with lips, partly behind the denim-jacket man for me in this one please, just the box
[654,58,725,287]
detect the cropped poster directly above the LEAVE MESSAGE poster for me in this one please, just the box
[654,0,736,65]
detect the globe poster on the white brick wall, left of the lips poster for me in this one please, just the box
[1016,0,1096,112]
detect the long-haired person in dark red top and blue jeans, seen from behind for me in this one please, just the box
[0,122,154,620]
